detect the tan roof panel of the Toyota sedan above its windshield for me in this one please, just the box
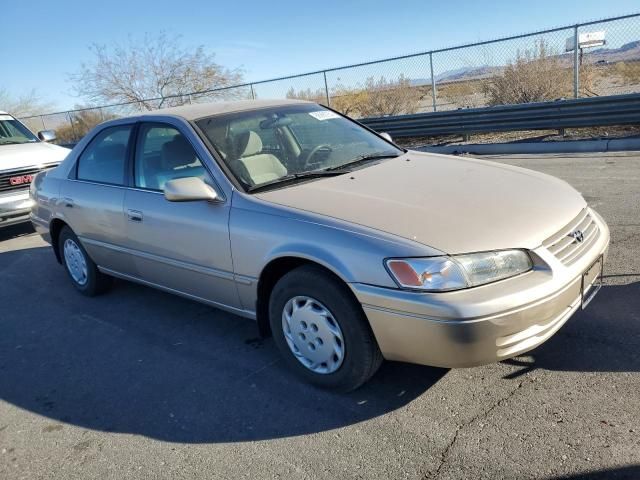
[145,99,313,120]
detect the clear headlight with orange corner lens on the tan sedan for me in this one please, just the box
[386,250,533,292]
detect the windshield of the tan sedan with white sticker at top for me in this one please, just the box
[196,104,403,190]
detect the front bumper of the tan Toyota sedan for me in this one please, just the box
[351,208,609,367]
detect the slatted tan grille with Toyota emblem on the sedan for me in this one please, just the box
[542,208,600,266]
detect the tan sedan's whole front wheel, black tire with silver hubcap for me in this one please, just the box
[269,266,382,392]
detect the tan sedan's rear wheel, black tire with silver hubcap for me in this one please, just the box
[58,226,112,297]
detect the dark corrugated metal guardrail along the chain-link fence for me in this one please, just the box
[359,93,640,138]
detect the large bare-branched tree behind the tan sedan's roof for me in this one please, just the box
[70,32,244,110]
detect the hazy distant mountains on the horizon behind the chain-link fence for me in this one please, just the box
[411,40,640,86]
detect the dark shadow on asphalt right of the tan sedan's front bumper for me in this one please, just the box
[504,282,640,378]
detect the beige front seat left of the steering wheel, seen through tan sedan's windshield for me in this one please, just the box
[236,130,287,185]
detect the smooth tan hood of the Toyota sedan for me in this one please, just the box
[256,152,586,254]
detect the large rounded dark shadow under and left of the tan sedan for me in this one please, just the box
[0,247,447,443]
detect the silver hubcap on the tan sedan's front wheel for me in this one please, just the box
[282,296,344,374]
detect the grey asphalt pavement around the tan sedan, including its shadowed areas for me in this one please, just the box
[0,153,640,480]
